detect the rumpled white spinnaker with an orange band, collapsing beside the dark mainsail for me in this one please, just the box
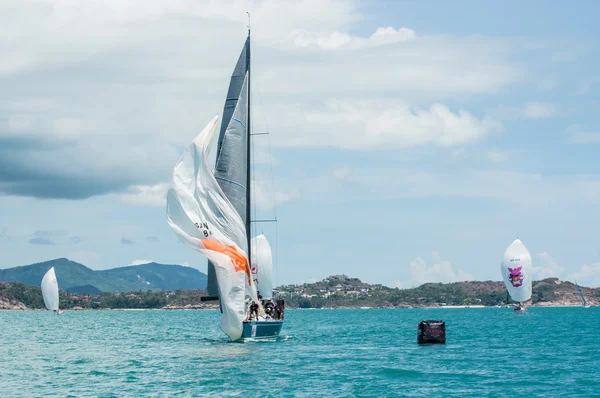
[167,116,256,340]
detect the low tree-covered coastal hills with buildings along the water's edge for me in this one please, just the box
[0,274,600,309]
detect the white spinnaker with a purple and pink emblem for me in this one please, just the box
[500,239,533,302]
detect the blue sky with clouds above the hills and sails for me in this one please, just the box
[0,0,600,288]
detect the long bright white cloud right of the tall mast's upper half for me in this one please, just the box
[277,100,501,150]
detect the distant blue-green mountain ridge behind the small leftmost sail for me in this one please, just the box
[0,258,207,293]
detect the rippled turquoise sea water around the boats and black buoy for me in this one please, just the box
[0,307,600,397]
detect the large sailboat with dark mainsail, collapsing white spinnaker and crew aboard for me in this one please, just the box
[167,30,283,341]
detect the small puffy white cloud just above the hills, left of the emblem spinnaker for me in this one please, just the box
[395,252,473,288]
